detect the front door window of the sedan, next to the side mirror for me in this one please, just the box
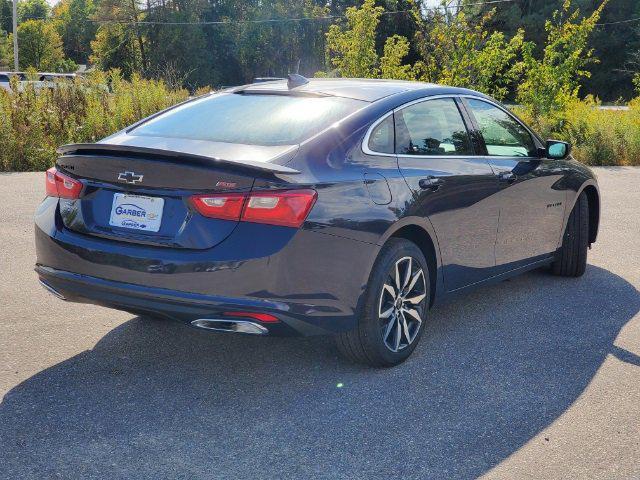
[467,98,537,157]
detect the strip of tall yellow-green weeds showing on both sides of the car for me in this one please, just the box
[0,71,640,171]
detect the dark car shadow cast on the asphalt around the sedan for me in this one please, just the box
[0,265,640,478]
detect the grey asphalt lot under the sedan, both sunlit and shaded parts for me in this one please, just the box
[0,168,640,479]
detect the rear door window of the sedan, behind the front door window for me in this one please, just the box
[395,98,473,155]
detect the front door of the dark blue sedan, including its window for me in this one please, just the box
[464,98,565,273]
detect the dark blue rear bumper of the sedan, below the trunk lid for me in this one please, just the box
[35,197,379,336]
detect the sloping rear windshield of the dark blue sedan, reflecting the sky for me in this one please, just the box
[129,93,366,145]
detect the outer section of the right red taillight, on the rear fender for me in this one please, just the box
[242,190,318,227]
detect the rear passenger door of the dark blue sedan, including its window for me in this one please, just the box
[394,97,498,291]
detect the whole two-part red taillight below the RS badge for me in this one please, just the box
[191,189,318,227]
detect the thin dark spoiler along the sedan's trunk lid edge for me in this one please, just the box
[56,143,300,175]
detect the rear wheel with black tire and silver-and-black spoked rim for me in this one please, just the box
[336,238,431,367]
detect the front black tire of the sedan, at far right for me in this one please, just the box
[551,192,589,277]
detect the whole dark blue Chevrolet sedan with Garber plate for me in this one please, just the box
[35,75,600,366]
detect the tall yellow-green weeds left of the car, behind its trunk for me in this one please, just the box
[0,71,188,171]
